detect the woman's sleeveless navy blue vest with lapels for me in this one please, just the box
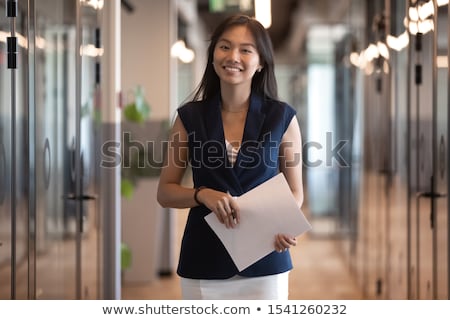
[177,95,295,279]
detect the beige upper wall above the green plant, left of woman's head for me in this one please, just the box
[121,0,177,120]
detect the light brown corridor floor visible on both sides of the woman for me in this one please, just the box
[122,212,363,300]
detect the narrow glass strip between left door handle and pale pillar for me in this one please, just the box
[78,1,103,299]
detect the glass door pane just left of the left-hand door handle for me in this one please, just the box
[34,0,78,299]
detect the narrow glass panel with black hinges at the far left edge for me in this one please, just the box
[0,1,32,299]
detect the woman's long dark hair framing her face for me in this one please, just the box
[192,15,278,101]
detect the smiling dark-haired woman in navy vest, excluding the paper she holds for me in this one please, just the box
[158,15,303,299]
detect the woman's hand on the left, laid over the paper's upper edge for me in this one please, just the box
[197,188,240,228]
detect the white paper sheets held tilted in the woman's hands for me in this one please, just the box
[205,173,311,271]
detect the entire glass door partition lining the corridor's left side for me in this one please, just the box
[0,0,108,299]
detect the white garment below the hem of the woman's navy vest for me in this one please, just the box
[181,271,289,300]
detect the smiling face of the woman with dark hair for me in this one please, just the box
[213,26,261,88]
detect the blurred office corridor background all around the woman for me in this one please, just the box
[0,0,450,300]
